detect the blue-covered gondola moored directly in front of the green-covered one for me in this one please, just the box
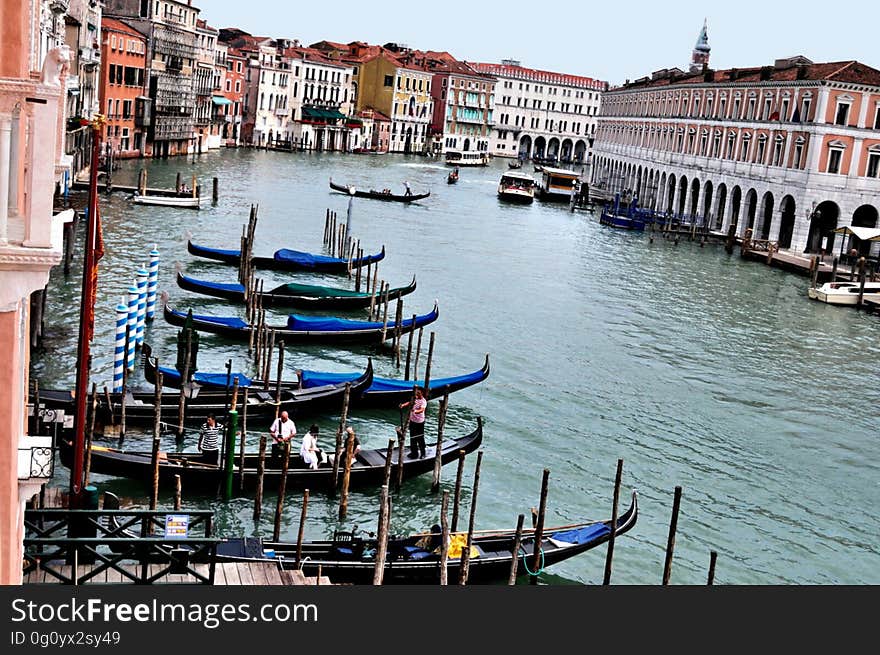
[163,302,440,344]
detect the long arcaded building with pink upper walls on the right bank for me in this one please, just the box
[591,52,880,253]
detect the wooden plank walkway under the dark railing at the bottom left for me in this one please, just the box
[23,562,333,586]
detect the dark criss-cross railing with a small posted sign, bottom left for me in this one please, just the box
[24,509,221,585]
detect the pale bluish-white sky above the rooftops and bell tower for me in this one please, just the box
[192,0,880,85]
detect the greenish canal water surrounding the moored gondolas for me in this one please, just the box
[32,150,880,585]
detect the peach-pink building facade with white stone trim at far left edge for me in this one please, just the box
[0,2,67,585]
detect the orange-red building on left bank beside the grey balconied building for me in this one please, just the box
[98,18,147,157]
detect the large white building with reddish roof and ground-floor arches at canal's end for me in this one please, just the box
[469,59,608,164]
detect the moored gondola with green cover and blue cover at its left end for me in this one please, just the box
[177,272,416,310]
